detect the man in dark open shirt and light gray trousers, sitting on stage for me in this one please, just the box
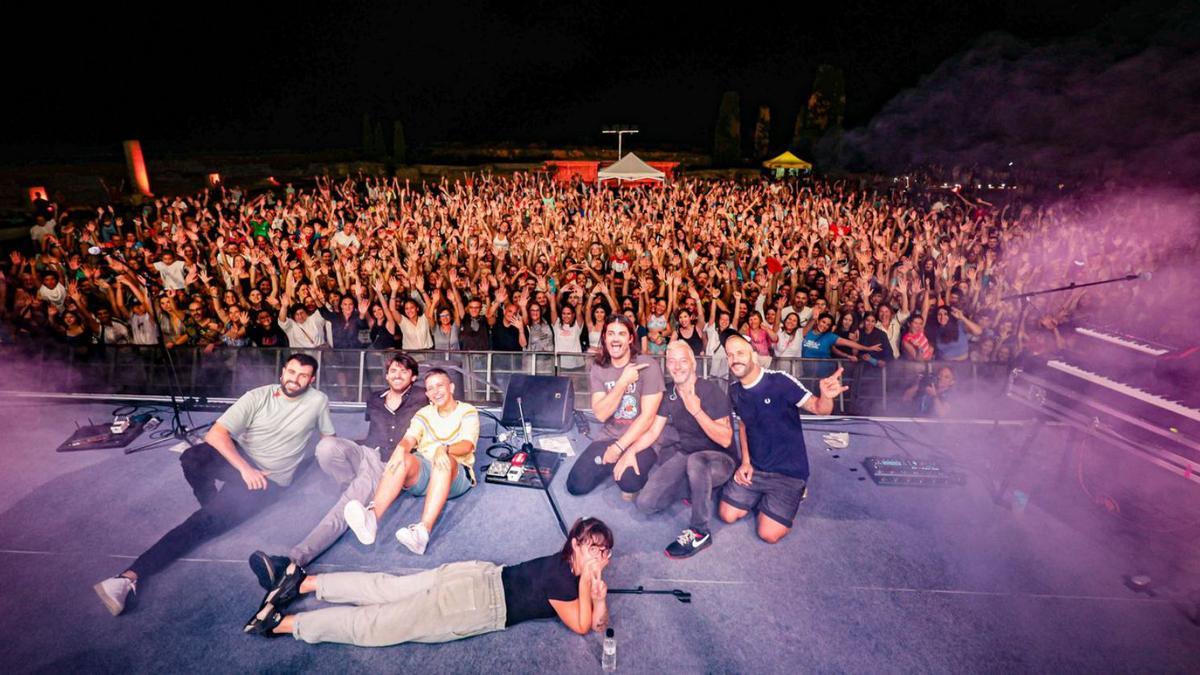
[243,352,428,590]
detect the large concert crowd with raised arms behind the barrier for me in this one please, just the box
[0,173,1194,375]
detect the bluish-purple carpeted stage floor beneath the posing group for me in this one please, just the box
[0,404,1200,673]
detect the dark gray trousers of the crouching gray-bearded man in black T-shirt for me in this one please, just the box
[637,449,734,532]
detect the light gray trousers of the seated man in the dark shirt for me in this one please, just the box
[288,436,383,566]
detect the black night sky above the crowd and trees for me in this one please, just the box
[0,1,1137,160]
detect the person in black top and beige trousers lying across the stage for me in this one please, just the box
[245,518,613,647]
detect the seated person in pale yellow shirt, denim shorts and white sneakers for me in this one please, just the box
[344,368,479,555]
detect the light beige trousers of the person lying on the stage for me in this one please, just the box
[292,561,508,647]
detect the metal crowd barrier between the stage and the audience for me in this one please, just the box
[0,341,1009,417]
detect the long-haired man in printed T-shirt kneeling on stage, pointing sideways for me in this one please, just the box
[566,313,662,497]
